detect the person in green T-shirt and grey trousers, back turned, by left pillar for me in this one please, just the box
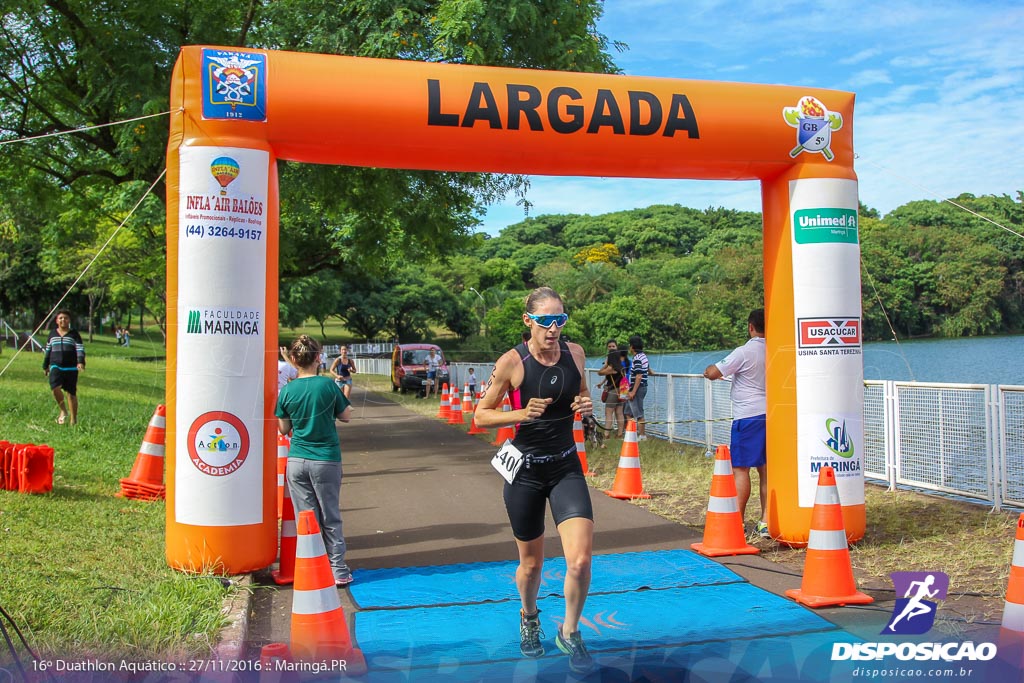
[274,335,352,586]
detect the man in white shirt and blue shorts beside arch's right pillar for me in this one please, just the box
[703,308,771,539]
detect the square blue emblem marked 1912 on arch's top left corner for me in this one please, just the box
[203,50,266,121]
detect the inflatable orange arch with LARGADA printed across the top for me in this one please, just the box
[166,46,865,573]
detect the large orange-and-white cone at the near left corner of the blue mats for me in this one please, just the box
[291,510,367,676]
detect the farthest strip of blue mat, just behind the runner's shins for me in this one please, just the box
[349,550,744,609]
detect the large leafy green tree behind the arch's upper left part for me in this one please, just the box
[0,0,615,342]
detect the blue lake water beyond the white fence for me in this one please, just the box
[587,335,1024,385]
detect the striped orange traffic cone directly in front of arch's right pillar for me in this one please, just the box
[785,465,874,607]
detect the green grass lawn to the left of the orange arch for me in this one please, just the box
[0,333,234,660]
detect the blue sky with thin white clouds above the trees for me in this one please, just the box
[482,0,1024,234]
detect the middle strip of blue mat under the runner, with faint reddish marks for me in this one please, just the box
[353,583,836,671]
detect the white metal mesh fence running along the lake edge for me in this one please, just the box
[357,358,1024,510]
